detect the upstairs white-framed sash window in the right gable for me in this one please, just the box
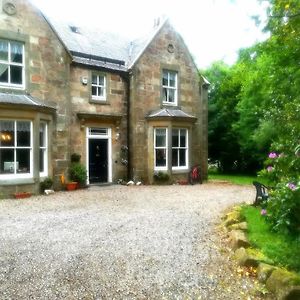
[162,70,178,105]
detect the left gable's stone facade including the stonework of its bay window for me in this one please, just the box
[0,0,71,196]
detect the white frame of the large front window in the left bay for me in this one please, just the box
[0,119,33,179]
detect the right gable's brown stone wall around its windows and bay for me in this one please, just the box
[130,22,207,182]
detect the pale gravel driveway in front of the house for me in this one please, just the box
[0,183,262,299]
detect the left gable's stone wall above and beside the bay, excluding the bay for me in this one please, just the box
[0,0,71,196]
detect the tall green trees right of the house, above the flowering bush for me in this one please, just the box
[204,0,300,172]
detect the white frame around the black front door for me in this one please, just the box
[86,126,112,184]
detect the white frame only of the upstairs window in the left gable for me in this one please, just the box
[0,39,25,90]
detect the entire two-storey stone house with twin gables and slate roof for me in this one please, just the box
[0,0,208,196]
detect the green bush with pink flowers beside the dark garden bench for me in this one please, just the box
[260,142,300,236]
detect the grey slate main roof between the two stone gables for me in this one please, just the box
[45,17,166,71]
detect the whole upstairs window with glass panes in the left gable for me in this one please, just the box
[0,40,25,89]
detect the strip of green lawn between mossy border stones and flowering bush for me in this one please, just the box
[241,206,300,274]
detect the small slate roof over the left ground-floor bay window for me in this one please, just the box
[0,93,55,110]
